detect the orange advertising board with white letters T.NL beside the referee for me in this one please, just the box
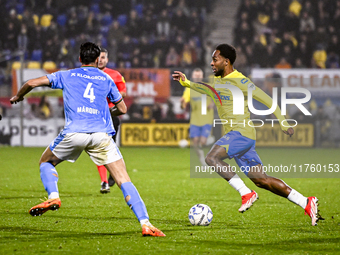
[118,68,170,98]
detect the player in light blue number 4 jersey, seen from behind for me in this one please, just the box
[10,42,165,236]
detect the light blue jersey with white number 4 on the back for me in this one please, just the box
[47,66,122,135]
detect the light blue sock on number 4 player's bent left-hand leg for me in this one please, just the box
[40,162,59,195]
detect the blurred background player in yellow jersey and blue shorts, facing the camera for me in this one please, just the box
[181,68,214,166]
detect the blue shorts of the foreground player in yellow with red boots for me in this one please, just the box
[215,131,262,175]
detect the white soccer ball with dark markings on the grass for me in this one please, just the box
[189,204,213,226]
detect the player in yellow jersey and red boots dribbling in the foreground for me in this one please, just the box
[172,44,322,226]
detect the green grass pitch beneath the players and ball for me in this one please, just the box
[0,147,340,255]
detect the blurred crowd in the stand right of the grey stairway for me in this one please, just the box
[234,0,340,73]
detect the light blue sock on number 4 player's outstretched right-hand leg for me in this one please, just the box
[120,182,149,221]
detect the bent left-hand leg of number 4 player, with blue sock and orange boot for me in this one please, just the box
[29,147,62,216]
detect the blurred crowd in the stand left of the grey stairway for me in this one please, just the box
[0,0,212,72]
